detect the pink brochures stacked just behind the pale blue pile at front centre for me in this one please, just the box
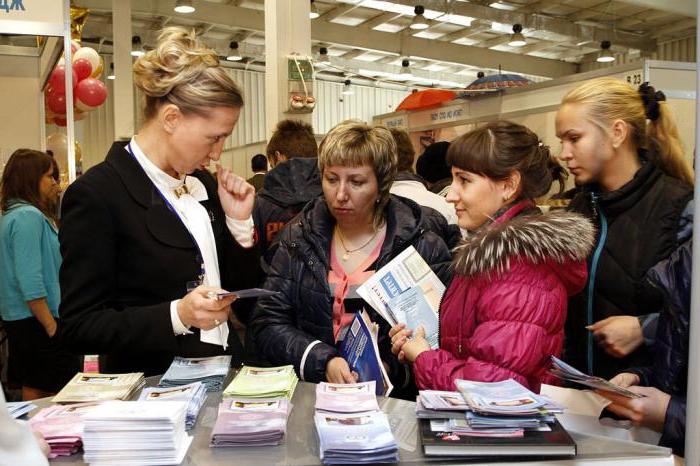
[316,380,379,413]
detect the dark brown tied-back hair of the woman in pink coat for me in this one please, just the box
[447,121,566,199]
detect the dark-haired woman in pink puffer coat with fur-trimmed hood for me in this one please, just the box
[390,121,594,392]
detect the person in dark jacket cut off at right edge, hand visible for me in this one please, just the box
[600,241,693,456]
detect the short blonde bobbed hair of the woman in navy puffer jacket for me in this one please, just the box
[318,120,397,227]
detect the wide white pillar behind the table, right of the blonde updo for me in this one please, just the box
[265,0,311,139]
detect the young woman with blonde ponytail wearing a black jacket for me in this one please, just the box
[556,78,693,378]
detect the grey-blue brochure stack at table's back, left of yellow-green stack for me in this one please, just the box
[158,356,231,392]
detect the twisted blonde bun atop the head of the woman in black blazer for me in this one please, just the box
[134,27,219,97]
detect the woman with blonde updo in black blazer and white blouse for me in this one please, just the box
[60,28,258,375]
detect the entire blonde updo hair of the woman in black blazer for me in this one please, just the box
[134,27,243,120]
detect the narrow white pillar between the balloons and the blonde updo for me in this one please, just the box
[112,0,134,140]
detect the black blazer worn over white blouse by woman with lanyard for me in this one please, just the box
[59,142,259,375]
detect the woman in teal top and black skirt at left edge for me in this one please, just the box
[0,149,79,400]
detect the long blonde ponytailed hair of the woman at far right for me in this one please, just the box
[561,77,693,185]
